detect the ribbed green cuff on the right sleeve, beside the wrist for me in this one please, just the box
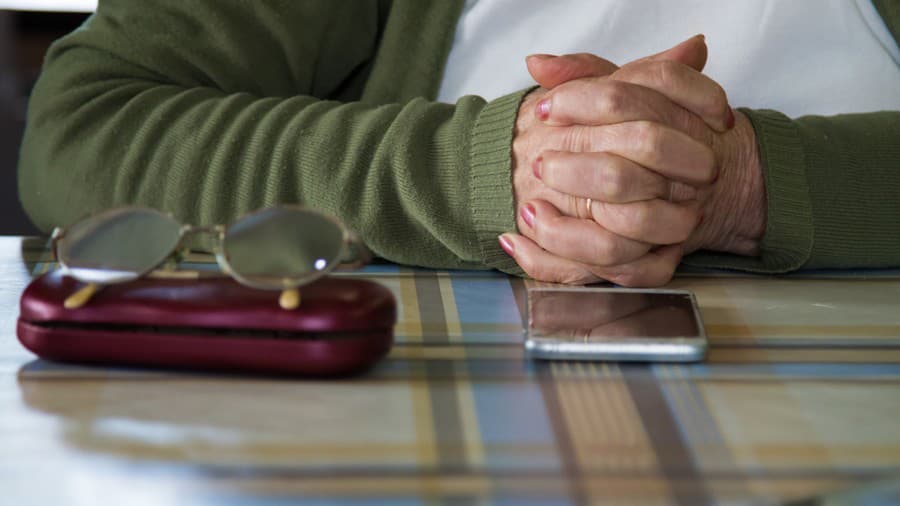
[685,109,813,274]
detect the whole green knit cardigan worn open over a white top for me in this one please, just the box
[19,0,900,272]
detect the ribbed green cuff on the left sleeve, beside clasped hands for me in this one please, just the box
[469,89,531,275]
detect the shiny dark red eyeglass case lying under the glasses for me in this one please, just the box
[16,272,397,376]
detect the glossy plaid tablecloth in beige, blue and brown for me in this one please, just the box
[0,238,900,506]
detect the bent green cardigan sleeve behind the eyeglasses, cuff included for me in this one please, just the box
[19,0,523,268]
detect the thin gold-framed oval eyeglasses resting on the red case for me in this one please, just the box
[52,205,369,309]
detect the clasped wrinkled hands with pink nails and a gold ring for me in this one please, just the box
[500,36,766,286]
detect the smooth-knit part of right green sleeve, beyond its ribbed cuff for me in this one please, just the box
[795,111,900,268]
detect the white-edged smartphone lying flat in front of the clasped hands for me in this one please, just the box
[525,287,707,362]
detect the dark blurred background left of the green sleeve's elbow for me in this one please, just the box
[0,5,92,235]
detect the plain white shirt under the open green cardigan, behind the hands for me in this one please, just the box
[438,0,900,117]
